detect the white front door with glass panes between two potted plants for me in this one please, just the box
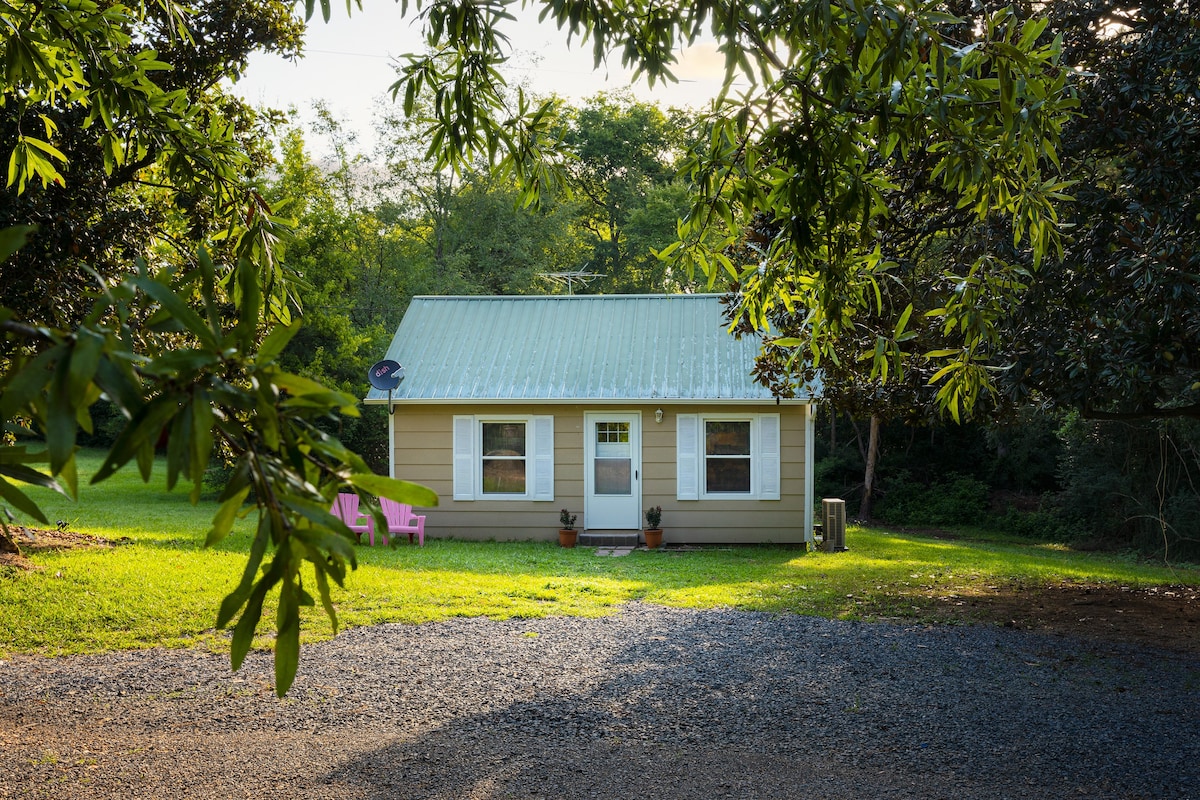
[583,411,642,530]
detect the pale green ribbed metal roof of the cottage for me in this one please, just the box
[366,295,816,403]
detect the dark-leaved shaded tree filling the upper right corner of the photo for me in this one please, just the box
[998,0,1200,420]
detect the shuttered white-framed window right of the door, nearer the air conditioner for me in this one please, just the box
[676,414,779,500]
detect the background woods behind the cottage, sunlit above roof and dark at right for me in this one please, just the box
[72,77,1200,560]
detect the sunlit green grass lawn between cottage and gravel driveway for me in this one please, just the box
[0,453,1200,655]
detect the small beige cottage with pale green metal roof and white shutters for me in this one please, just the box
[366,295,814,543]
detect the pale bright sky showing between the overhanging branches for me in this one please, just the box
[225,0,724,150]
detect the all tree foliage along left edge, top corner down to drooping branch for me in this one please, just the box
[0,0,427,693]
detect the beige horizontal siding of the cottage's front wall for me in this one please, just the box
[391,403,810,543]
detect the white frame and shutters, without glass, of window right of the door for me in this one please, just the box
[676,414,781,500]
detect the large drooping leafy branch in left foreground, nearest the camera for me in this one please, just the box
[0,237,437,694]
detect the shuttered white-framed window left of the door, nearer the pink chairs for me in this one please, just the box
[454,415,554,500]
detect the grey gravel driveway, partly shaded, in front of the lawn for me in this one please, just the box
[0,603,1200,800]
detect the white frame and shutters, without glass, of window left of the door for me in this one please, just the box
[452,414,554,501]
